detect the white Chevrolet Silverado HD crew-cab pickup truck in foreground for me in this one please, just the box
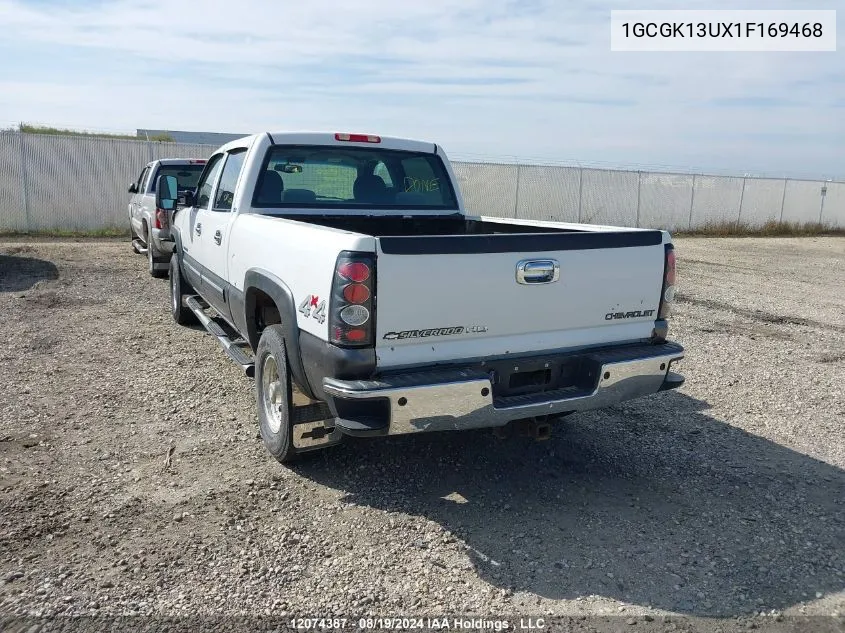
[156,133,684,462]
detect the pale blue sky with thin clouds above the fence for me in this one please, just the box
[0,0,845,179]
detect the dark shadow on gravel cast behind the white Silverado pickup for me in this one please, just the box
[297,392,845,616]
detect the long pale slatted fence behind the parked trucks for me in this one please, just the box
[0,132,845,232]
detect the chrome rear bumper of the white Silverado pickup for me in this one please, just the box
[323,343,684,435]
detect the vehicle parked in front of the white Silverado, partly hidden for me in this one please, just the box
[129,158,206,277]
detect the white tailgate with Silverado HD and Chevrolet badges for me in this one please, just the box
[376,230,665,369]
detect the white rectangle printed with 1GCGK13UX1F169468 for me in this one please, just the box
[610,9,836,52]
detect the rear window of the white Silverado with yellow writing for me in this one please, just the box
[253,145,457,209]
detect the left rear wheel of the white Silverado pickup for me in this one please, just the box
[255,325,299,464]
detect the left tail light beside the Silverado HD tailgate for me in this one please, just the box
[329,251,375,347]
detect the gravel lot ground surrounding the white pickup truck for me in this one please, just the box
[0,238,845,631]
